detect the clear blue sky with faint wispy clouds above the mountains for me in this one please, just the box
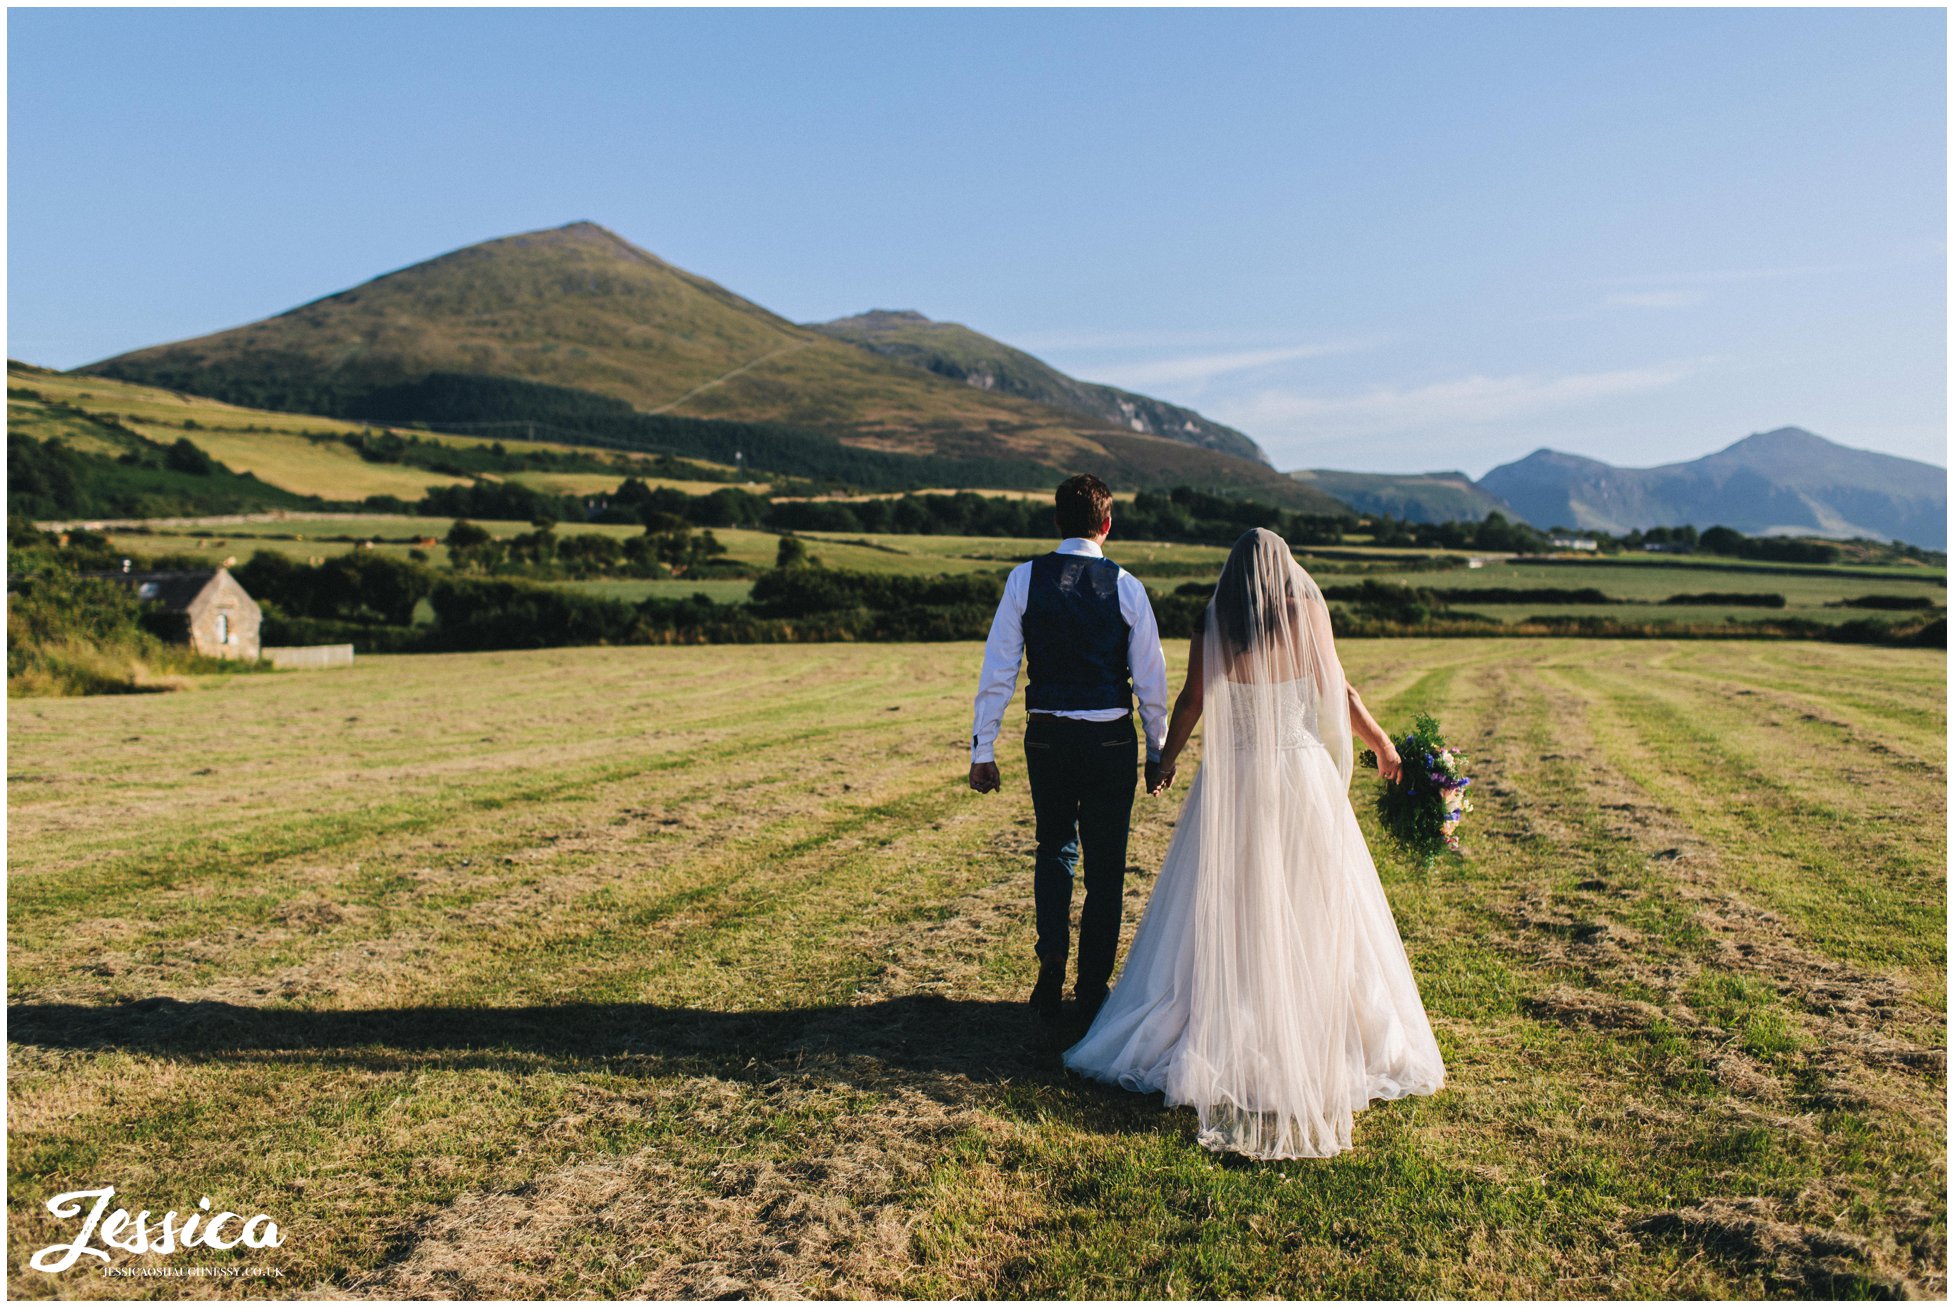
[8,10,1946,475]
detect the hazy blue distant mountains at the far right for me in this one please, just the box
[1477,426,1948,549]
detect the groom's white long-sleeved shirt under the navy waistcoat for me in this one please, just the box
[971,536,1167,763]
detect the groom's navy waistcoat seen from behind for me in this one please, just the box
[1024,553,1133,712]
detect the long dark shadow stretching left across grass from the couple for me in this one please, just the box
[8,995,1161,1109]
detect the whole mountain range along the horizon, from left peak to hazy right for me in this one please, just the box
[61,223,1946,549]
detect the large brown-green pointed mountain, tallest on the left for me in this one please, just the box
[80,223,1340,512]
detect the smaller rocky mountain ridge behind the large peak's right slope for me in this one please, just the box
[813,309,1268,463]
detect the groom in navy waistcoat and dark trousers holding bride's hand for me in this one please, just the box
[971,475,1167,1025]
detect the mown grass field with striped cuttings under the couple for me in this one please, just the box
[8,639,1946,1298]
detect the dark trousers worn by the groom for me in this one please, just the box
[1024,714,1139,995]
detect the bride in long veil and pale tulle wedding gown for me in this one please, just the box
[1065,528,1444,1157]
